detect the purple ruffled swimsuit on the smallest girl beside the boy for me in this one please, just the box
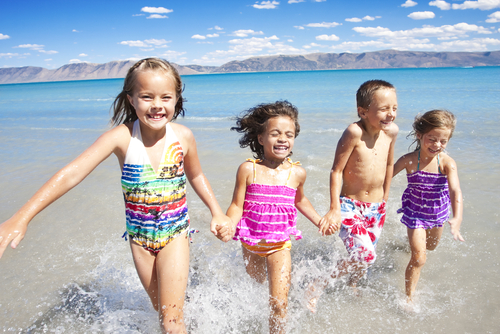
[398,156,451,229]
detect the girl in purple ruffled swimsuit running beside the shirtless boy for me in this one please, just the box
[393,110,464,305]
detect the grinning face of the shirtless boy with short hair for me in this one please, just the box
[358,88,398,131]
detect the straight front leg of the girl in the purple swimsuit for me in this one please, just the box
[405,228,427,301]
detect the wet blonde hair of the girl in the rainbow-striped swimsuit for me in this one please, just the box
[111,58,185,125]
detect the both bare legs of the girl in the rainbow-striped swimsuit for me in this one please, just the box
[130,235,189,333]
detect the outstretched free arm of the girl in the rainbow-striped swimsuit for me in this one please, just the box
[0,125,130,257]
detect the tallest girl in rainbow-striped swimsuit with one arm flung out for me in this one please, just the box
[0,58,232,333]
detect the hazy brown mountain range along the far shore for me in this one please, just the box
[0,50,500,84]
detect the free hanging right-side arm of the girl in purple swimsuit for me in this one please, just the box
[443,156,465,241]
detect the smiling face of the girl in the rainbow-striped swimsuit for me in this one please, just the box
[127,70,178,130]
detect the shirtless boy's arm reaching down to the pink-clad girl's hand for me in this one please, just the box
[319,124,361,231]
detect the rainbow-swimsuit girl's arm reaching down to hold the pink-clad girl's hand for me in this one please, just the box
[177,124,231,242]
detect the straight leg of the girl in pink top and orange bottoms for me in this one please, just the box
[267,249,292,333]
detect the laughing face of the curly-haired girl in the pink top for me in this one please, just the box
[258,116,295,161]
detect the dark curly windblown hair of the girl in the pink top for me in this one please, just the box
[231,100,300,159]
